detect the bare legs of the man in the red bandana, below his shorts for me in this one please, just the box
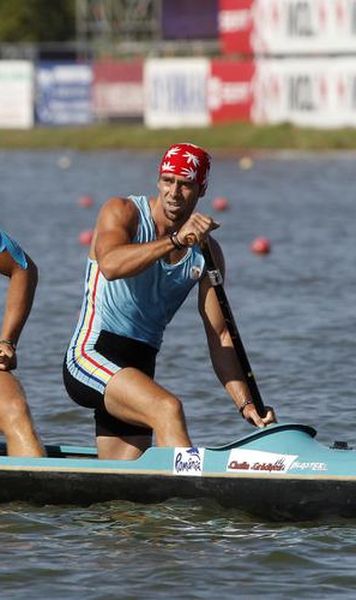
[98,367,192,458]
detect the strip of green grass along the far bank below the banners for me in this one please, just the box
[0,123,356,153]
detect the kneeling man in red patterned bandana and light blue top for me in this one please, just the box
[64,143,275,459]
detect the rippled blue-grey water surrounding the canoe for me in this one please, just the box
[0,152,356,600]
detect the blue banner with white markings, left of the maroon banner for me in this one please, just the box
[36,62,93,125]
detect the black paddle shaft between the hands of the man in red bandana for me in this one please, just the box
[201,241,266,417]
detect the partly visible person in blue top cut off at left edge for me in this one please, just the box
[0,229,44,457]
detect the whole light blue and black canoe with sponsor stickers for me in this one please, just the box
[0,423,356,520]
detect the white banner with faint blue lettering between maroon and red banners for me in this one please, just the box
[144,58,210,128]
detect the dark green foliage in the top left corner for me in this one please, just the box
[0,0,75,43]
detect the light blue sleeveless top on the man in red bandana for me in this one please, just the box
[85,196,205,349]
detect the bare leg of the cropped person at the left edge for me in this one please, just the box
[0,371,45,457]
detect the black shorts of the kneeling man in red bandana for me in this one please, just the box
[63,331,157,437]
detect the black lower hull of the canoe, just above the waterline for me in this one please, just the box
[0,470,356,520]
